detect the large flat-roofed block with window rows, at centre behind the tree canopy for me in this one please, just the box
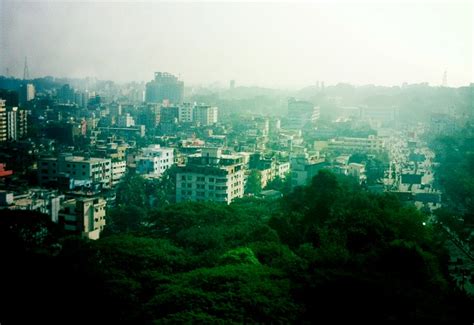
[176,148,244,204]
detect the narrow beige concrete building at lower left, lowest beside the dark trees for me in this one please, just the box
[58,198,107,239]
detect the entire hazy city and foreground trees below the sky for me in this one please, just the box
[0,1,474,325]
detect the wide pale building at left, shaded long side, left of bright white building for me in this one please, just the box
[38,155,111,188]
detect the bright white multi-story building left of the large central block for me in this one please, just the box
[136,144,174,177]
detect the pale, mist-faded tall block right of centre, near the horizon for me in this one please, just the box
[285,98,320,130]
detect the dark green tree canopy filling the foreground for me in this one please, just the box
[0,170,474,324]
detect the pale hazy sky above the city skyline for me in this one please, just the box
[0,0,474,87]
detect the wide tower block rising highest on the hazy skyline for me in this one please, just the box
[145,72,184,104]
